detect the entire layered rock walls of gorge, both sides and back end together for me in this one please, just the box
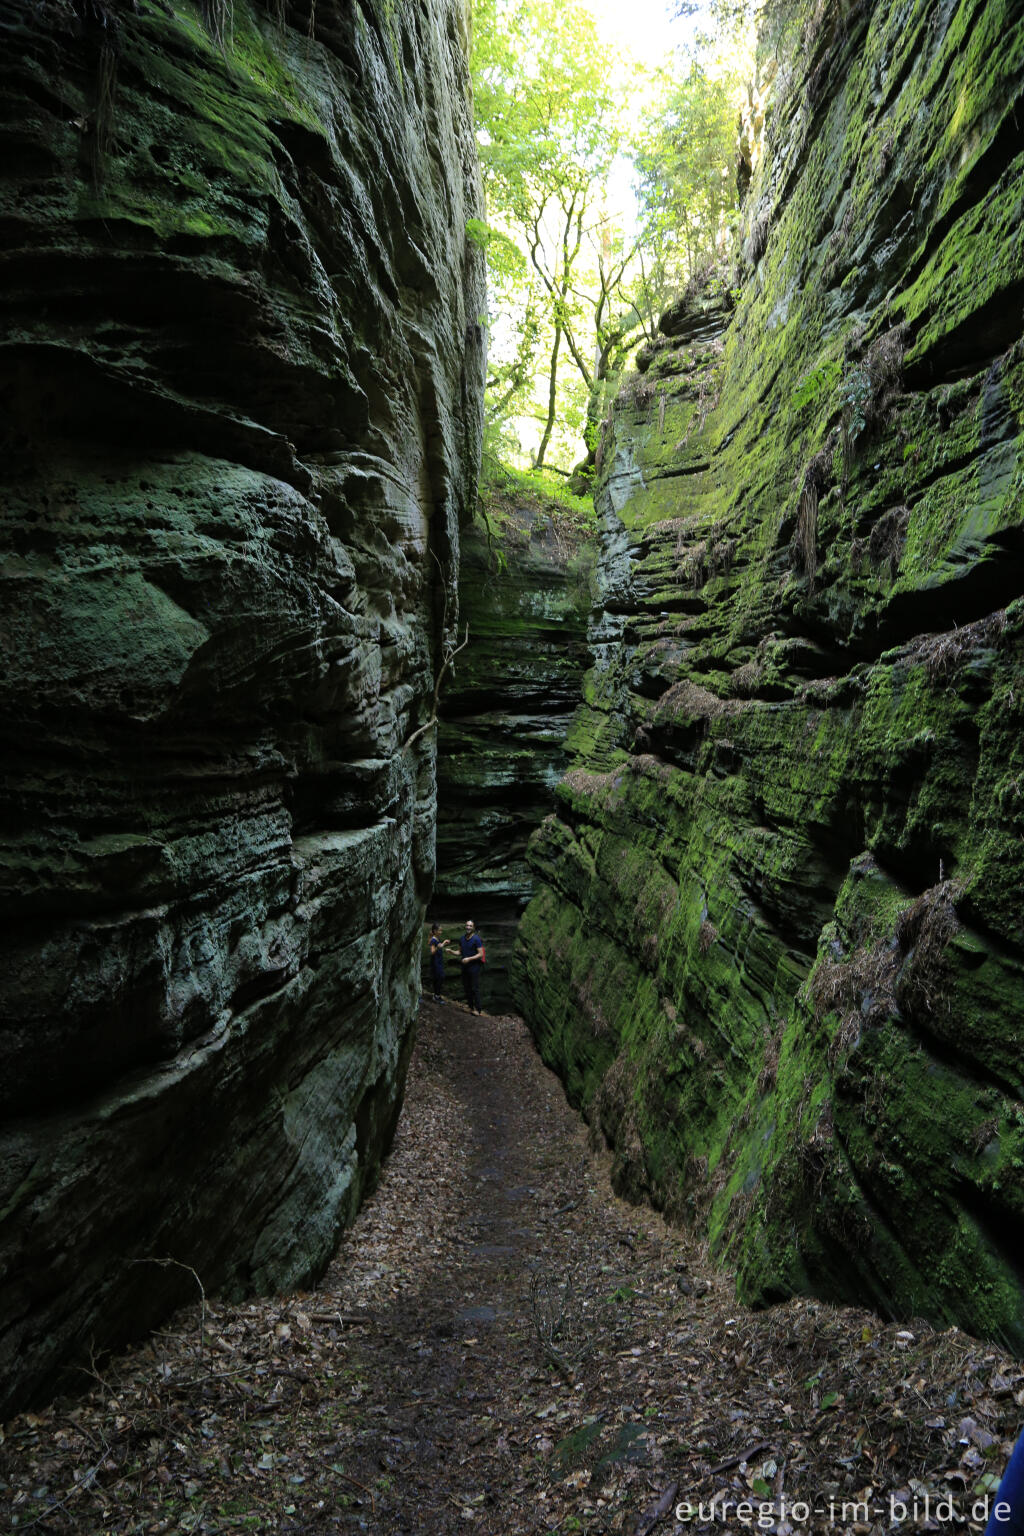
[0,0,1024,1425]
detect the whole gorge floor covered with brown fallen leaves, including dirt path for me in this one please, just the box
[0,1005,1024,1536]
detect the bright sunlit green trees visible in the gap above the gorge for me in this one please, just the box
[470,0,752,479]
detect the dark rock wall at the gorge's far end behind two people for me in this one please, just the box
[430,496,596,1012]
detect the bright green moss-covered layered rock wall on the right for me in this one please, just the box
[516,0,1024,1349]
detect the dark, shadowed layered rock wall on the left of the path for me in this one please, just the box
[0,0,484,1412]
